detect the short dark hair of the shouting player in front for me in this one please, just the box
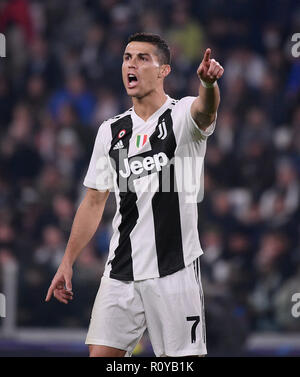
[128,33,171,64]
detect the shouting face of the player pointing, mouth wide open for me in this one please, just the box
[122,42,168,98]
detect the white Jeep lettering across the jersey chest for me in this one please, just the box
[119,152,169,178]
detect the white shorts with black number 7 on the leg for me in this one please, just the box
[85,258,207,357]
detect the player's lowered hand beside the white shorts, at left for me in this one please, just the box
[45,264,73,304]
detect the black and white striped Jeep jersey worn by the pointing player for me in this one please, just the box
[84,97,215,281]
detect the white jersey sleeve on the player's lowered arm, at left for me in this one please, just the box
[83,123,113,191]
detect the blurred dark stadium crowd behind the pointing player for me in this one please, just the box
[0,0,300,356]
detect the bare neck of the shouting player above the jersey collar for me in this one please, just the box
[132,92,167,121]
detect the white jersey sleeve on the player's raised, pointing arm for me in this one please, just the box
[178,97,217,141]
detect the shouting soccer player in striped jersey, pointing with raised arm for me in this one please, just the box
[46,33,224,357]
